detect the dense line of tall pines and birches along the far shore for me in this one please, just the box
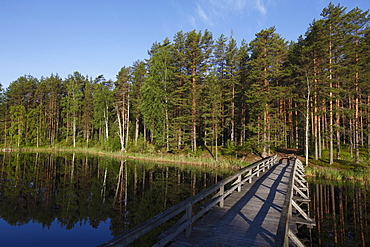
[0,3,370,163]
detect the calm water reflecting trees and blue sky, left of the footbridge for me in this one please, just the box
[0,153,230,246]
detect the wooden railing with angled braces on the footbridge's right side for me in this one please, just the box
[275,158,316,247]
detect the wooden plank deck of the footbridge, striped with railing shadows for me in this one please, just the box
[171,159,291,246]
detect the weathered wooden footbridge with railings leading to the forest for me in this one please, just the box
[101,155,315,247]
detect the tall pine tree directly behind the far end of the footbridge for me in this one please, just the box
[246,27,287,157]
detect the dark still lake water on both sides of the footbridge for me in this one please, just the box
[0,153,370,247]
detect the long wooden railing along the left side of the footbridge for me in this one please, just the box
[100,155,277,246]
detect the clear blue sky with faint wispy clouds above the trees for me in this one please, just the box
[0,0,370,88]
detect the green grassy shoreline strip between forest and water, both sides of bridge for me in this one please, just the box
[9,144,370,182]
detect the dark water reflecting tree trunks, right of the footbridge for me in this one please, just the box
[301,180,370,246]
